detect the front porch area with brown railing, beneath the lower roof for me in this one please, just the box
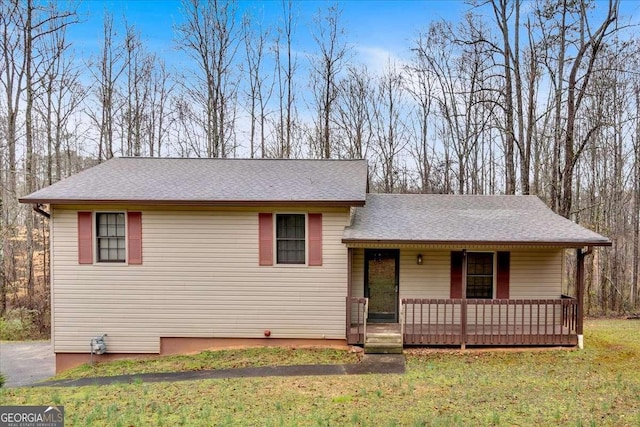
[346,246,591,350]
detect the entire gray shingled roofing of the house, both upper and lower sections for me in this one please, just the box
[20,158,610,246]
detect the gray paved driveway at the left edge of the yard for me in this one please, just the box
[0,341,56,387]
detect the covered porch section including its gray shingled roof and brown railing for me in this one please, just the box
[342,194,611,351]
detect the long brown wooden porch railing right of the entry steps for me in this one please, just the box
[402,298,578,346]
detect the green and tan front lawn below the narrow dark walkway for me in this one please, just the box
[0,320,640,426]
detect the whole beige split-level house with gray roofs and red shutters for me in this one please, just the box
[20,158,611,371]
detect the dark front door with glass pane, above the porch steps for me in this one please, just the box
[364,249,400,323]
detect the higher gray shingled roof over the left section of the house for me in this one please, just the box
[20,157,367,206]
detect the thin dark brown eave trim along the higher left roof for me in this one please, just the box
[18,197,365,207]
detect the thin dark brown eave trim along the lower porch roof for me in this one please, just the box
[342,238,612,248]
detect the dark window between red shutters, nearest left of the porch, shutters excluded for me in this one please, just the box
[276,214,305,264]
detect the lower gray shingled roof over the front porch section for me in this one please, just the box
[342,194,611,247]
